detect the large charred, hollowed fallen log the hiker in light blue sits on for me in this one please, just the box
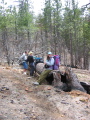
[36,63,86,92]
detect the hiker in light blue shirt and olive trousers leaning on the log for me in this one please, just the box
[34,52,54,85]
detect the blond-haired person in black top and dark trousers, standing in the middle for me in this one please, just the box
[26,51,35,76]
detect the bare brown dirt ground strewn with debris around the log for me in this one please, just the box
[0,66,90,120]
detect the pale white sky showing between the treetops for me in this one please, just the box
[0,0,90,15]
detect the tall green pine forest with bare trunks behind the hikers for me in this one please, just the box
[0,0,90,70]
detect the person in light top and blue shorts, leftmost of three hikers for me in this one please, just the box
[19,51,28,74]
